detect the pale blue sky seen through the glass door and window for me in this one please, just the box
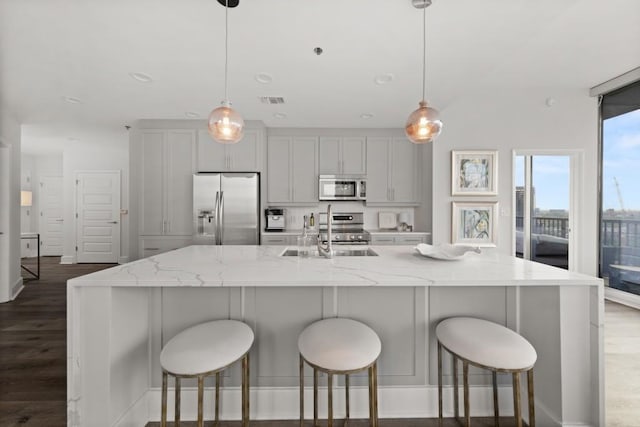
[515,110,640,210]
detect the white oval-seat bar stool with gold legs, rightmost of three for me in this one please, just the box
[436,317,538,427]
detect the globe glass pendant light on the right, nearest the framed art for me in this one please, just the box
[405,0,442,144]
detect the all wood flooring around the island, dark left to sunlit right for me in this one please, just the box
[0,257,640,427]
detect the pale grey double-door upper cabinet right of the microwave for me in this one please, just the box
[366,137,420,206]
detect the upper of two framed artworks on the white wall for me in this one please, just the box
[451,150,498,196]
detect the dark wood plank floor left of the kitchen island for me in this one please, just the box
[0,257,111,427]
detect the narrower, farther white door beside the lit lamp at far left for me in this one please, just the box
[38,176,63,256]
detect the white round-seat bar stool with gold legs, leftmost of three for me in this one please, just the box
[160,320,253,427]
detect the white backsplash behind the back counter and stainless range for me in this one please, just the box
[269,202,414,230]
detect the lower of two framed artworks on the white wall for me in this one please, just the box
[451,202,498,246]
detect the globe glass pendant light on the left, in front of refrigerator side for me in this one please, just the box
[208,0,244,144]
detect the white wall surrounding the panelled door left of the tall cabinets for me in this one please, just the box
[61,129,129,264]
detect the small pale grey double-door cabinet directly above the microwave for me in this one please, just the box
[319,136,367,175]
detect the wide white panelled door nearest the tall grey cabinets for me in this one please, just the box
[76,171,120,263]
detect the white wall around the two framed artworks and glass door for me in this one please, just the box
[433,89,599,275]
